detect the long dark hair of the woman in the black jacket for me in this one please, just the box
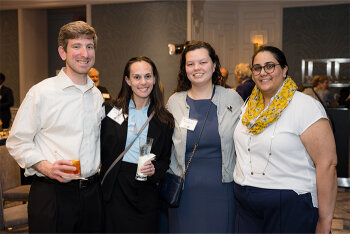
[111,56,174,128]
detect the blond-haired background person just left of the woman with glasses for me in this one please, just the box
[235,63,255,101]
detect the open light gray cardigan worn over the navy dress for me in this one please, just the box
[167,85,243,183]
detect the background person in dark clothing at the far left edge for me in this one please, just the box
[0,73,13,128]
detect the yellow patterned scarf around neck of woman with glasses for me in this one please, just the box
[242,77,297,135]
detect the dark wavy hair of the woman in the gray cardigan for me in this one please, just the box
[175,41,222,92]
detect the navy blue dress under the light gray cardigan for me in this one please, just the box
[169,97,234,233]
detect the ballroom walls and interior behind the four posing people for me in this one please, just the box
[0,0,350,233]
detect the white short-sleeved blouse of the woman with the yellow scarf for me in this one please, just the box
[233,92,327,207]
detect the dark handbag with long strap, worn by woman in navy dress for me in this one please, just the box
[159,86,215,208]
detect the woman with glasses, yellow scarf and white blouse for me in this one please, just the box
[234,46,337,233]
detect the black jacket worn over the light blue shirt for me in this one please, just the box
[101,102,173,200]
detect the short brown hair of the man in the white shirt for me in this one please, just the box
[58,21,97,51]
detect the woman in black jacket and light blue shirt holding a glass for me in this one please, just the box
[101,56,174,233]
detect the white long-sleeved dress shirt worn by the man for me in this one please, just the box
[6,68,104,177]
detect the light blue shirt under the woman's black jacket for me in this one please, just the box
[123,99,149,164]
